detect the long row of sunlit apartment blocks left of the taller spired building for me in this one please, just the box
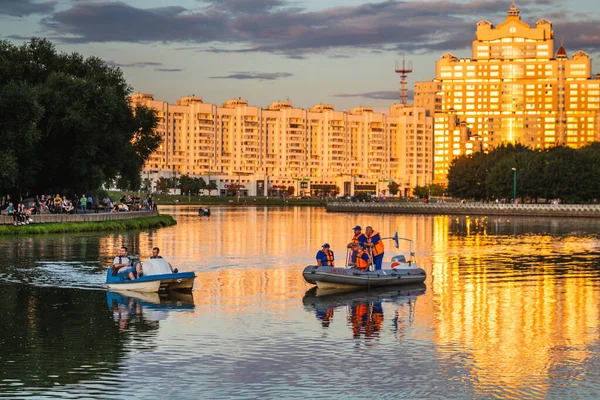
[130,93,433,196]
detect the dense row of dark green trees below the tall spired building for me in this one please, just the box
[447,143,600,203]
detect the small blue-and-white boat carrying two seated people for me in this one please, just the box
[106,258,196,293]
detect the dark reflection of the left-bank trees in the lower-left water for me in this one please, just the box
[0,284,158,392]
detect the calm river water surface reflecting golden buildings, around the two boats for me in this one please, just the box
[0,207,600,399]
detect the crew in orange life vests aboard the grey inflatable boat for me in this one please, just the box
[316,225,384,271]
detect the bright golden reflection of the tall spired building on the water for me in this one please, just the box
[428,217,600,396]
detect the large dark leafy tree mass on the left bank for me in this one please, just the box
[0,39,161,198]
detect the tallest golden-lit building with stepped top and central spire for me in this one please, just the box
[415,3,600,183]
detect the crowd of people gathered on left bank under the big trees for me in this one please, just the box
[0,193,156,226]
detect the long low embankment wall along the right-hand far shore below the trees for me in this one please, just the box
[327,202,600,218]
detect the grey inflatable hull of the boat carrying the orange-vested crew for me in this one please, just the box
[302,265,427,289]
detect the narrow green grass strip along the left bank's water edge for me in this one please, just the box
[0,215,177,235]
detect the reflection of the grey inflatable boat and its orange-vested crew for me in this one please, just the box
[302,284,426,341]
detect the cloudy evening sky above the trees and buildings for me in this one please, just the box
[0,0,600,111]
